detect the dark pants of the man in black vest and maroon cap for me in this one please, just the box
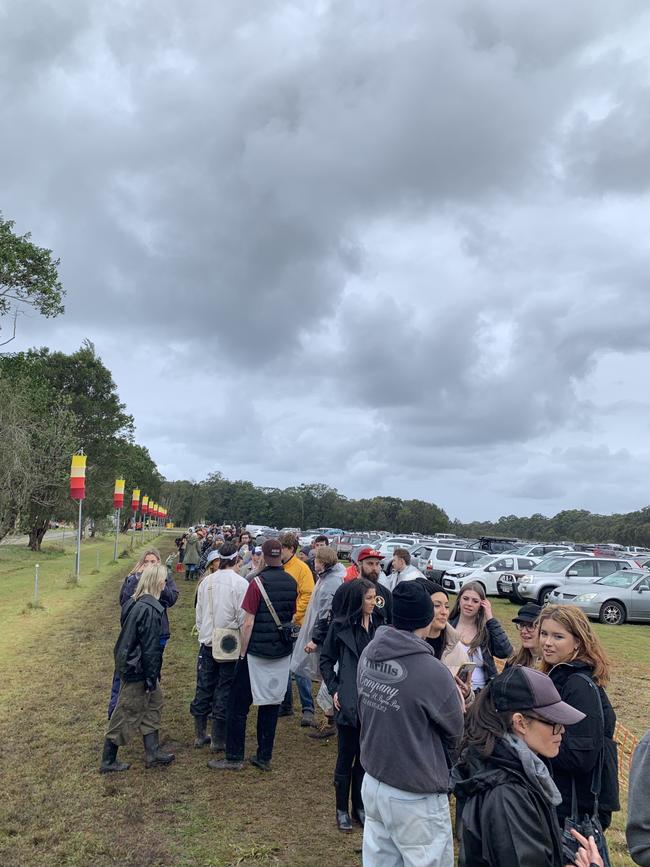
[226,659,280,762]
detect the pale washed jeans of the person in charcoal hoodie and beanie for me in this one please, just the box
[361,773,454,867]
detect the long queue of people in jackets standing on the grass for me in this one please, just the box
[100,526,650,867]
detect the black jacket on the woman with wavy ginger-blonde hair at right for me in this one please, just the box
[548,660,621,828]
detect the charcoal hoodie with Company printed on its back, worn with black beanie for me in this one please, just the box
[357,626,463,794]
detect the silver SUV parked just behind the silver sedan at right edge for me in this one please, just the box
[516,554,637,605]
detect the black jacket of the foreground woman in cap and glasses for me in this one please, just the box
[452,740,564,867]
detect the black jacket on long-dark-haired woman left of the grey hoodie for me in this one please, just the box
[320,618,374,726]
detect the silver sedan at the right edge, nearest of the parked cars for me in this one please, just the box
[549,569,650,626]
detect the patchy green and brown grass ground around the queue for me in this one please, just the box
[0,536,650,867]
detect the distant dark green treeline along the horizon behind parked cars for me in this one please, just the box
[161,473,650,547]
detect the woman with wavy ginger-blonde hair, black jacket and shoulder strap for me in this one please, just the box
[539,605,621,830]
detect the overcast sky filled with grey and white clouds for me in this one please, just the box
[0,0,650,520]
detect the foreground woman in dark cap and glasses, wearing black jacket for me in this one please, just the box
[452,666,603,867]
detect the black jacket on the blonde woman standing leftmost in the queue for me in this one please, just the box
[113,594,163,689]
